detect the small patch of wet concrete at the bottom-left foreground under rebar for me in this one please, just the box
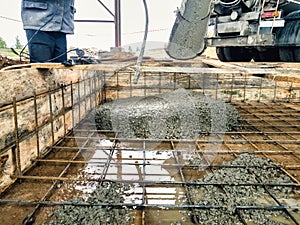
[42,183,133,225]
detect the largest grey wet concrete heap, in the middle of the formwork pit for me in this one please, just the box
[90,89,240,139]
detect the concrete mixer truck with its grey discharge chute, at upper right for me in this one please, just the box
[166,0,300,62]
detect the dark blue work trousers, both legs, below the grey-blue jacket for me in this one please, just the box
[25,30,67,63]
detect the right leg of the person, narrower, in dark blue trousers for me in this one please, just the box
[53,32,67,62]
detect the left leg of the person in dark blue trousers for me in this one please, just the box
[26,30,55,63]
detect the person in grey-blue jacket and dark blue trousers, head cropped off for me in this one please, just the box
[21,0,75,63]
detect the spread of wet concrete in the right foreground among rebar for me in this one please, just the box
[189,154,296,225]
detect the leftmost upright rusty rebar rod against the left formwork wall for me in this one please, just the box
[13,97,22,176]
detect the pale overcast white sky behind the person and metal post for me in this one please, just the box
[0,0,181,50]
